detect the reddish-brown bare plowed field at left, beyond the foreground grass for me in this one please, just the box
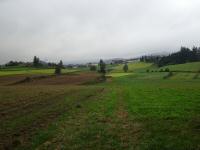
[0,72,99,85]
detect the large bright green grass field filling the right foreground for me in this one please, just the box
[28,76,200,149]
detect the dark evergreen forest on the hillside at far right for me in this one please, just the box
[140,47,200,67]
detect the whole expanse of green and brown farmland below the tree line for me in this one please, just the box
[0,62,200,150]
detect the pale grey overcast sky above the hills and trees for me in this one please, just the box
[0,0,200,63]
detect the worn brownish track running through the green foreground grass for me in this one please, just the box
[111,88,142,149]
